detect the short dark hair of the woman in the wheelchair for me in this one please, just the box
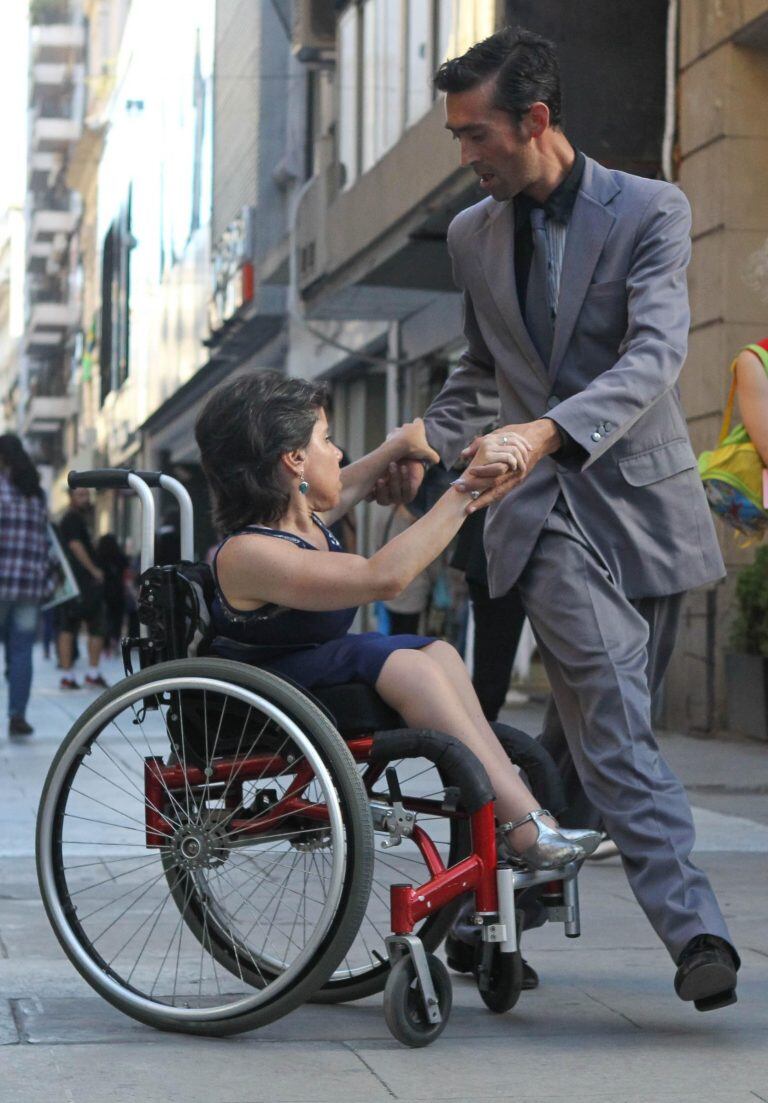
[194,372,328,535]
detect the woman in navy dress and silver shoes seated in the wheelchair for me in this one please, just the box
[195,373,600,869]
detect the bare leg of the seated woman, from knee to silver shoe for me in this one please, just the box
[375,641,551,849]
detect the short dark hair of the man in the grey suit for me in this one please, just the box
[434,26,563,127]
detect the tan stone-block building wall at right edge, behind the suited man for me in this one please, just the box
[666,0,768,731]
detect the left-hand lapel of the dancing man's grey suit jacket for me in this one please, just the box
[476,203,550,388]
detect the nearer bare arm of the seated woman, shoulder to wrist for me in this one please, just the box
[216,489,476,612]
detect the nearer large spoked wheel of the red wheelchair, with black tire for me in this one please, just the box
[38,660,373,1035]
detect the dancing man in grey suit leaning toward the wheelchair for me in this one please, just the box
[380,29,739,1010]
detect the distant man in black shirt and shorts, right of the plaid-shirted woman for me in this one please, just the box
[58,486,107,689]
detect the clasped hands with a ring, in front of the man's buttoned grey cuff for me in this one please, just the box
[459,418,562,512]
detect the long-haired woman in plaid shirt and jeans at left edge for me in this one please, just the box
[0,432,52,737]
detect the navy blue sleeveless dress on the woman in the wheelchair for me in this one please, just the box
[211,516,435,689]
